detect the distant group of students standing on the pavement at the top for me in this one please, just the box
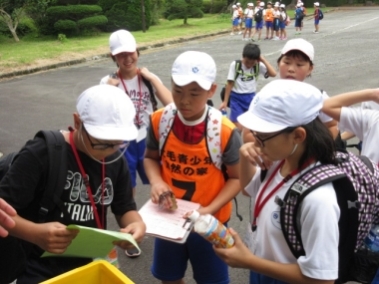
[231,0,323,41]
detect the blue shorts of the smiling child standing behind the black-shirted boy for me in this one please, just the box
[124,139,149,188]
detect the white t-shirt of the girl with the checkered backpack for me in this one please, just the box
[245,162,340,280]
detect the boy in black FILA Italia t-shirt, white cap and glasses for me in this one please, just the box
[0,85,145,284]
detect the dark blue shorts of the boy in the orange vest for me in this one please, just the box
[151,233,230,284]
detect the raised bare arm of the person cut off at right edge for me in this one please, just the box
[322,88,379,121]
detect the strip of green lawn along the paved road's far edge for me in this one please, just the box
[0,14,231,74]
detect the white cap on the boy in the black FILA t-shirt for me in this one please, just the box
[76,84,138,141]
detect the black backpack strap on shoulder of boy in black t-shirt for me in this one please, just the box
[35,131,67,223]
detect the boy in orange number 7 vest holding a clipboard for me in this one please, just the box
[144,51,241,283]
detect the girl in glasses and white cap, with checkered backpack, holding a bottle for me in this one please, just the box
[214,80,340,284]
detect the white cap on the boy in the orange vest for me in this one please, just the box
[171,51,217,91]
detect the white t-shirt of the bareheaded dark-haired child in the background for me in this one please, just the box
[227,61,267,94]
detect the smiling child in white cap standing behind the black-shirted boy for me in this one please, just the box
[100,30,172,257]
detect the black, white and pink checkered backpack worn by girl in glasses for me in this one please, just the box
[261,152,379,283]
